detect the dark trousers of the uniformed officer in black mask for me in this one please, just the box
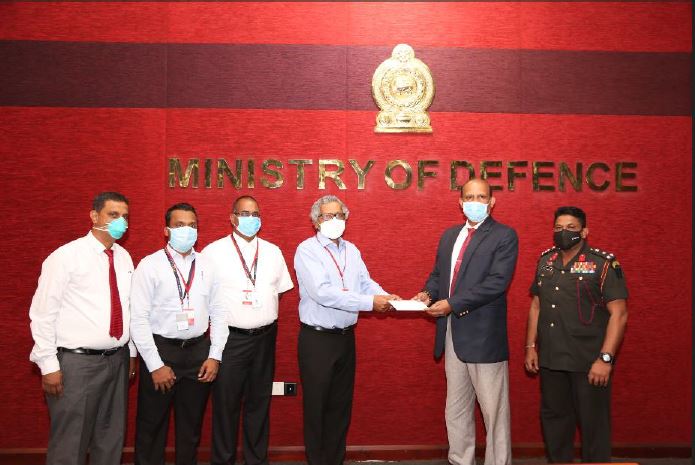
[540,368,611,463]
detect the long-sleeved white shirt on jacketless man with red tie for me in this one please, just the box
[29,231,136,375]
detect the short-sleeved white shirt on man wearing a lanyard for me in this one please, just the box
[202,233,294,329]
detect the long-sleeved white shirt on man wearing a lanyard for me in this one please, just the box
[130,244,229,372]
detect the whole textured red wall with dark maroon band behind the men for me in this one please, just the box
[0,2,692,449]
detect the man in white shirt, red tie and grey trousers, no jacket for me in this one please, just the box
[29,192,136,465]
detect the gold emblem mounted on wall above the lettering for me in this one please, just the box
[372,44,434,132]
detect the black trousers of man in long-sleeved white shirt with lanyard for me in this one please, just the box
[135,335,210,465]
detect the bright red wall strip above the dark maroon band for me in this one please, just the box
[0,2,692,52]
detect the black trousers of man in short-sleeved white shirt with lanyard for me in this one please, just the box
[210,323,277,465]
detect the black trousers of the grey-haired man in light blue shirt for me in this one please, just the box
[298,326,355,465]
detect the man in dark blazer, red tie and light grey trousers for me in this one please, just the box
[415,179,518,465]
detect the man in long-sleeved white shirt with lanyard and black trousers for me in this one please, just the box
[130,203,227,465]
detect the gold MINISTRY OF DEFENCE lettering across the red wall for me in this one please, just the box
[167,157,639,193]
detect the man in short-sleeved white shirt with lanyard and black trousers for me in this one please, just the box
[203,196,294,465]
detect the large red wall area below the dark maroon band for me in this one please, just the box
[0,108,691,447]
